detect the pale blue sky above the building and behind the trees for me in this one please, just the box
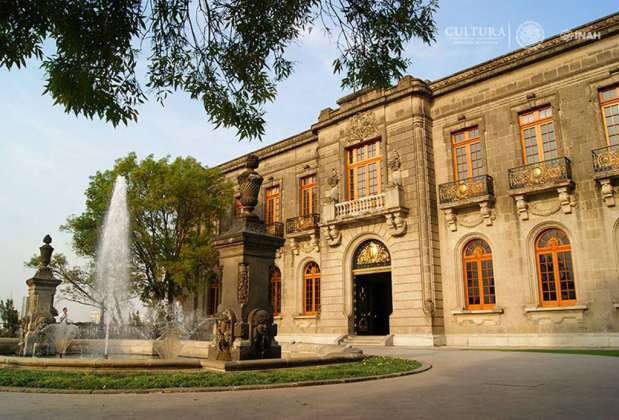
[0,0,618,320]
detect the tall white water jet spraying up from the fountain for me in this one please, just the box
[95,176,130,358]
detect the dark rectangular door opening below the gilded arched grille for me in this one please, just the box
[353,272,392,335]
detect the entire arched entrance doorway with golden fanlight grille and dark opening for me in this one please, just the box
[352,239,393,335]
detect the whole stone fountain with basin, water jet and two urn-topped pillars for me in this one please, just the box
[0,161,363,371]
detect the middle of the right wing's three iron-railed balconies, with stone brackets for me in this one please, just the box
[508,157,575,220]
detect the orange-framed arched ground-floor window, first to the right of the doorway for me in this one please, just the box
[462,239,496,309]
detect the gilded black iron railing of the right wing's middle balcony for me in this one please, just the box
[508,157,572,190]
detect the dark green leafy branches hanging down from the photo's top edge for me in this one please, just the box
[0,0,438,138]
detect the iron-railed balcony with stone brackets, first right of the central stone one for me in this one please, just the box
[438,175,495,231]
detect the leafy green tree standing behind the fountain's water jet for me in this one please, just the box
[63,153,232,304]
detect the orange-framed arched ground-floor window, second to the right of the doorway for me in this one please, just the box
[535,228,576,306]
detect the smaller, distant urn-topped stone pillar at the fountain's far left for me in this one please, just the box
[20,235,62,356]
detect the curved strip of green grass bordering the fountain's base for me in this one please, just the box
[0,356,420,390]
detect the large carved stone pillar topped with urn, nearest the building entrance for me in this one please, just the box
[209,155,284,361]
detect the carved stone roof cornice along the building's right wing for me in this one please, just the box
[430,13,619,96]
